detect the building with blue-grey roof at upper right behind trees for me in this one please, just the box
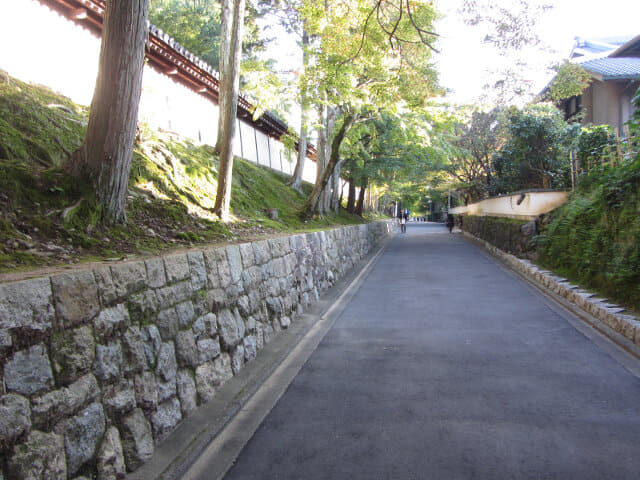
[543,35,640,136]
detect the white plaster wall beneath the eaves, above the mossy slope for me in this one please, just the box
[0,0,315,181]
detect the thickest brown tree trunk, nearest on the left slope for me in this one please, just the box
[65,0,149,224]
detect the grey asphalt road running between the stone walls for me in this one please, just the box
[208,224,640,480]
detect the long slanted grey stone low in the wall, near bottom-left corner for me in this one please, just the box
[31,373,100,430]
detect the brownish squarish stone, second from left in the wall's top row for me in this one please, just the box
[51,271,100,328]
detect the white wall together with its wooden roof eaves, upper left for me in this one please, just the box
[0,0,316,182]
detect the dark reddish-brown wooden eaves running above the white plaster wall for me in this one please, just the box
[38,0,316,159]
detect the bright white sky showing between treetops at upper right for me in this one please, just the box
[436,0,640,103]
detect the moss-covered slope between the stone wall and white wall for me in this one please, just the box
[0,72,376,272]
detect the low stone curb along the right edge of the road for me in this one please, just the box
[462,231,640,358]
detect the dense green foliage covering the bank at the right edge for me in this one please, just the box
[539,159,640,310]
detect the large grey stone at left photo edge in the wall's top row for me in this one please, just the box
[0,278,55,340]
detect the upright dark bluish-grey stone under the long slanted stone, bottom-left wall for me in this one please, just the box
[64,403,106,475]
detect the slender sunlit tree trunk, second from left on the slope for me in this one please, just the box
[213,0,245,222]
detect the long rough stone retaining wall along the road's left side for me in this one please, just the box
[0,222,394,480]
